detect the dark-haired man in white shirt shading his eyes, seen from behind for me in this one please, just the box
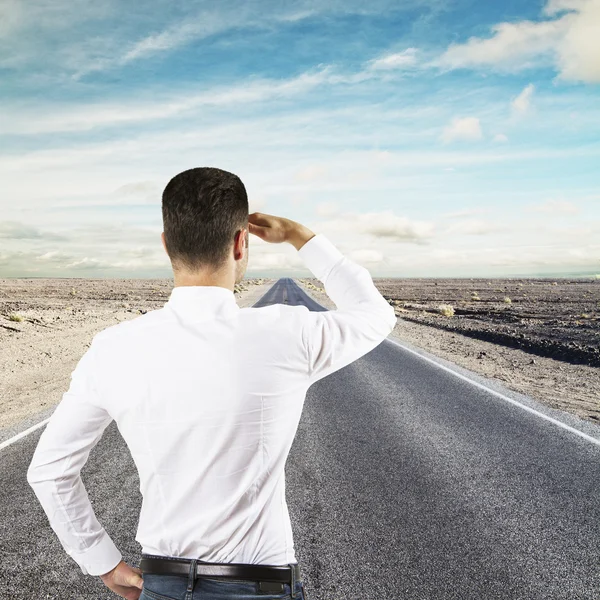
[27,167,396,600]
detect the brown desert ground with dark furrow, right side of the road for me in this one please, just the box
[297,278,600,424]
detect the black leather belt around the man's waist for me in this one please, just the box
[140,554,300,593]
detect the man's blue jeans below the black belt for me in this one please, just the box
[139,573,306,600]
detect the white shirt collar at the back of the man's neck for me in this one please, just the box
[165,285,239,319]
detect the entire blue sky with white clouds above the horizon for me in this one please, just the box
[0,0,600,278]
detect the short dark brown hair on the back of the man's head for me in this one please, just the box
[162,167,248,271]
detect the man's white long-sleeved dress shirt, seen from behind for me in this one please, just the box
[27,234,396,575]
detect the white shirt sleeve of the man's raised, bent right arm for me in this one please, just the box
[298,233,397,384]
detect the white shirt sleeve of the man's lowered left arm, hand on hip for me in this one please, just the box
[27,341,122,575]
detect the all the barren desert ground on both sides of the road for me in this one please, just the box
[0,278,600,436]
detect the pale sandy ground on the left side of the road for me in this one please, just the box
[0,278,275,439]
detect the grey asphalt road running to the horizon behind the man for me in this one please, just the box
[0,278,600,600]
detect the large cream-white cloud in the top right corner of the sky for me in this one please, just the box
[438,0,600,83]
